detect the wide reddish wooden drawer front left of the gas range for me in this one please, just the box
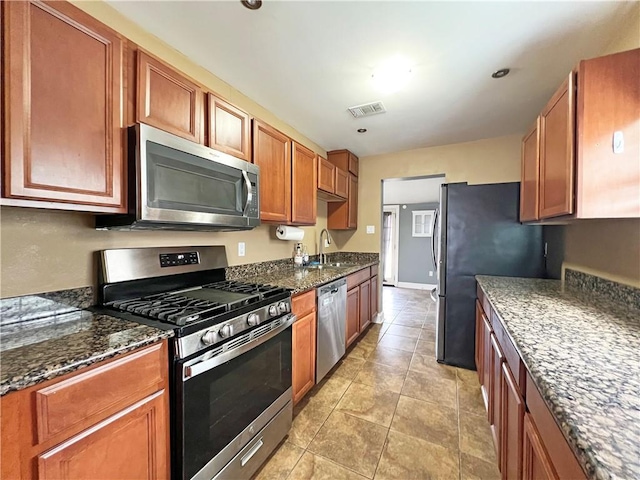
[35,342,168,443]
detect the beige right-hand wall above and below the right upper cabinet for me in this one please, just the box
[563,3,640,287]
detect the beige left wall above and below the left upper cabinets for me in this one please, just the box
[0,2,336,297]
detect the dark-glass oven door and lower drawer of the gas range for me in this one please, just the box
[174,315,295,479]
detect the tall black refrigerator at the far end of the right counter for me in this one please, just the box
[434,182,545,369]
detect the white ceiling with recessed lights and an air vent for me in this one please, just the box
[109,0,633,156]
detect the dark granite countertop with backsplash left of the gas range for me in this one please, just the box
[0,291,173,395]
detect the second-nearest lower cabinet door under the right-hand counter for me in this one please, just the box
[500,362,524,480]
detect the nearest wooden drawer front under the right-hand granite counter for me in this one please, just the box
[526,374,586,480]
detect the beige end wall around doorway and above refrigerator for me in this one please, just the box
[334,135,521,252]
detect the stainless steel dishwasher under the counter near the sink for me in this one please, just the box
[316,278,347,383]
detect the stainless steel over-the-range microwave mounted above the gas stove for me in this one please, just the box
[96,124,260,231]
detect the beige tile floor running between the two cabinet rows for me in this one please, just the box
[255,287,500,480]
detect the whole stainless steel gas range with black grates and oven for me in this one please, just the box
[100,247,295,480]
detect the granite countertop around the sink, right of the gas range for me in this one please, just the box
[245,261,378,295]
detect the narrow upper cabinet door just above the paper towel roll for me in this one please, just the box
[291,142,318,225]
